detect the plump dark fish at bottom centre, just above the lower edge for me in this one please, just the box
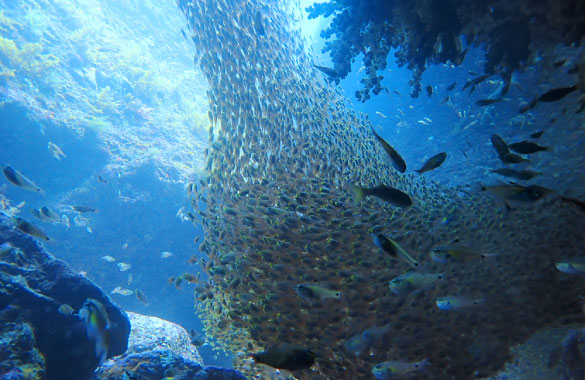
[252,343,317,371]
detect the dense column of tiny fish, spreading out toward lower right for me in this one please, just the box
[178,0,585,380]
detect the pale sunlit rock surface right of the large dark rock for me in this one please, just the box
[125,312,203,365]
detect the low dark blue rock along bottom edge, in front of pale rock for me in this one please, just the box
[94,348,246,380]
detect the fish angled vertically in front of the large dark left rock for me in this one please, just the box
[78,298,110,365]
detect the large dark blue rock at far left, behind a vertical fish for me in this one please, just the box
[0,215,130,380]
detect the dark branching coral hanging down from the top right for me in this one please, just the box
[307,0,585,101]
